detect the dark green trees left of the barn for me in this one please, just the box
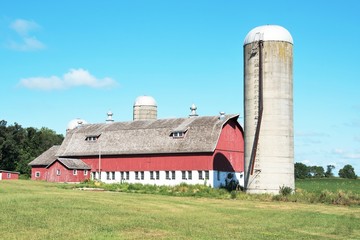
[0,120,64,175]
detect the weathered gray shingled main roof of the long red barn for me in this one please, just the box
[57,115,239,157]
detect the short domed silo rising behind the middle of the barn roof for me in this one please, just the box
[133,96,157,121]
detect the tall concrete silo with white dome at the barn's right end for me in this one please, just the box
[244,25,295,194]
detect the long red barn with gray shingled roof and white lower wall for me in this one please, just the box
[30,115,244,187]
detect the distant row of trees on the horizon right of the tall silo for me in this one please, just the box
[295,163,357,179]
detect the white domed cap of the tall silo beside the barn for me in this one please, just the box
[244,25,294,45]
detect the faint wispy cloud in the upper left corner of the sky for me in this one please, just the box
[9,19,46,51]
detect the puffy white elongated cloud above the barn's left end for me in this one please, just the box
[18,68,117,90]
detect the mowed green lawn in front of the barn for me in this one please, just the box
[0,180,360,239]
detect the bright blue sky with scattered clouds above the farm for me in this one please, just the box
[0,0,360,175]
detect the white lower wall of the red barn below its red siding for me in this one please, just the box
[91,170,244,188]
